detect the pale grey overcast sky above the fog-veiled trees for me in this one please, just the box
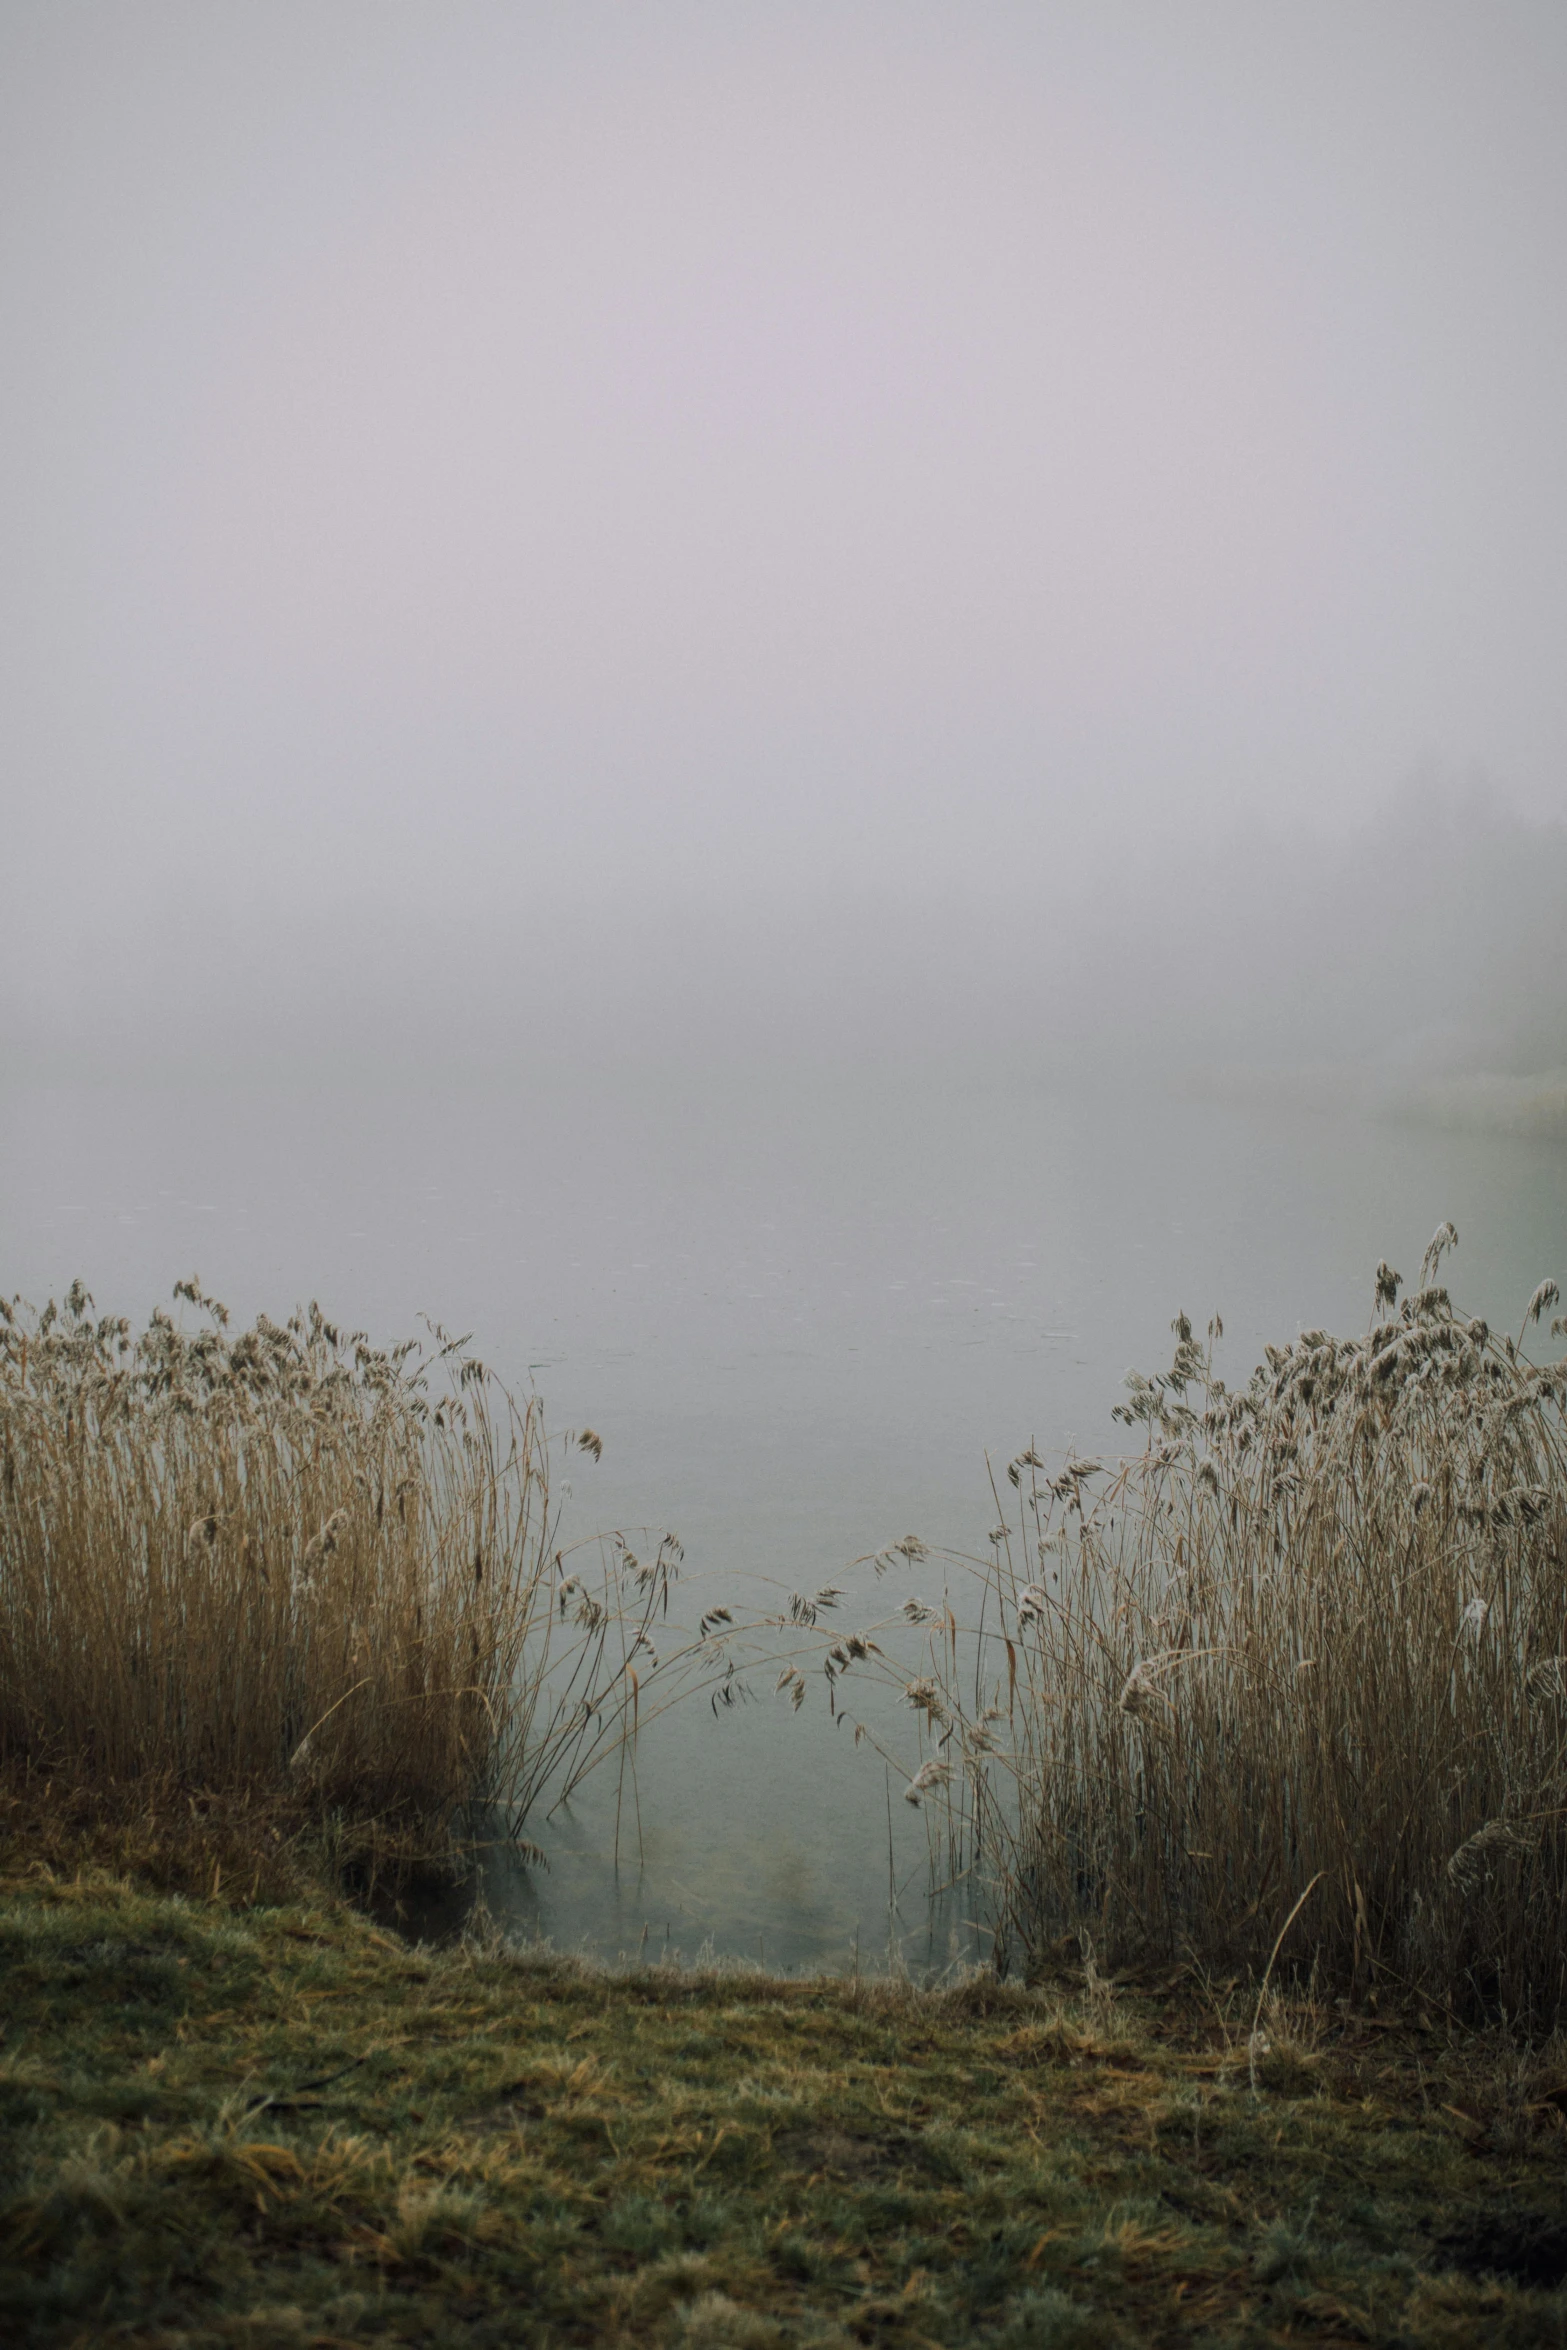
[0,0,1567,1066]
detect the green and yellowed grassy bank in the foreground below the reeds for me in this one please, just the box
[0,1845,1567,2350]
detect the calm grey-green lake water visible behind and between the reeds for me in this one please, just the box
[0,1081,1567,1967]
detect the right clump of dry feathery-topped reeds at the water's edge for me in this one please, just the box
[859,1224,1567,2028]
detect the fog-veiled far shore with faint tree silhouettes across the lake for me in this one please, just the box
[0,773,1567,1140]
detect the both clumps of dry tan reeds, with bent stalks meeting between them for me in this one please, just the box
[15,1224,1567,2037]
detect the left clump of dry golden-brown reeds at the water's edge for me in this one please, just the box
[0,1281,679,1849]
